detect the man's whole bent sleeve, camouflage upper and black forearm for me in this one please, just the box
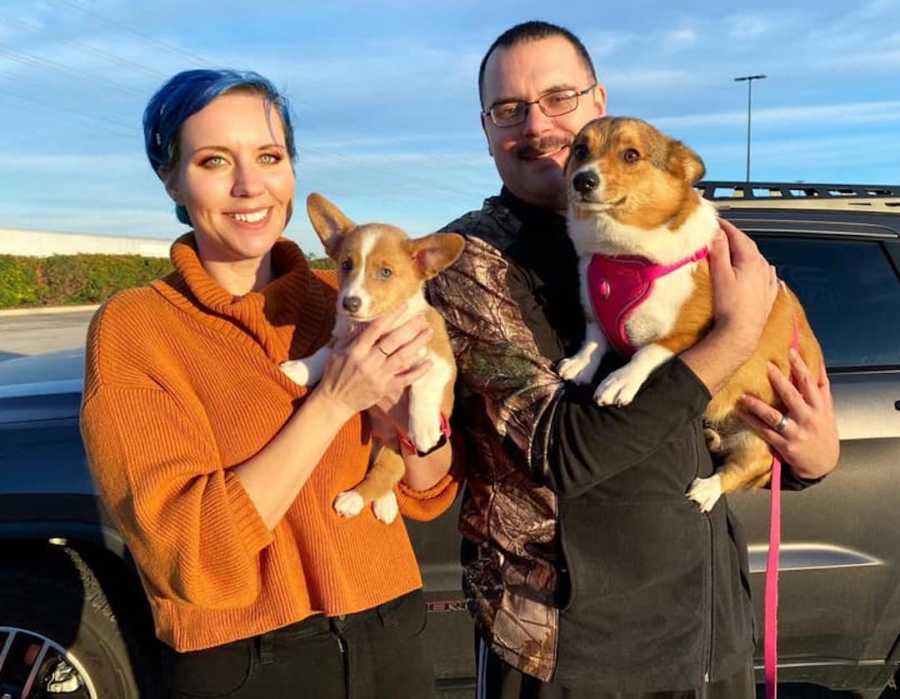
[428,239,710,504]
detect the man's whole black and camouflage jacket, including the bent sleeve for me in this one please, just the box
[429,190,808,691]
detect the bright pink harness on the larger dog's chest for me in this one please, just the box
[587,248,709,357]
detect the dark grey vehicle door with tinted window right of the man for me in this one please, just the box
[730,218,900,687]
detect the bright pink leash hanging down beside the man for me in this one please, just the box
[763,318,800,699]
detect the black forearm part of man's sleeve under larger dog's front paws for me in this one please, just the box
[532,356,710,497]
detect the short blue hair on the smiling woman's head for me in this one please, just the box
[144,69,297,226]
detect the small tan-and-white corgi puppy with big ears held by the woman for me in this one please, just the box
[281,194,465,524]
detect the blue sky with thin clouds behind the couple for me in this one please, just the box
[0,0,900,253]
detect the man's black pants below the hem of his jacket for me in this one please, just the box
[475,629,756,699]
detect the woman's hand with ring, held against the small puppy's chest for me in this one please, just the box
[316,309,433,418]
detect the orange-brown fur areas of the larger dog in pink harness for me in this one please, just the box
[566,117,822,504]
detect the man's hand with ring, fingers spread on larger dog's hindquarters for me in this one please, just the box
[737,349,840,480]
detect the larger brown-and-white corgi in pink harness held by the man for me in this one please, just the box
[558,117,822,512]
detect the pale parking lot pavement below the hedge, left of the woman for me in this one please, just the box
[0,310,94,361]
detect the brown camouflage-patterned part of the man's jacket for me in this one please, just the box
[428,197,574,681]
